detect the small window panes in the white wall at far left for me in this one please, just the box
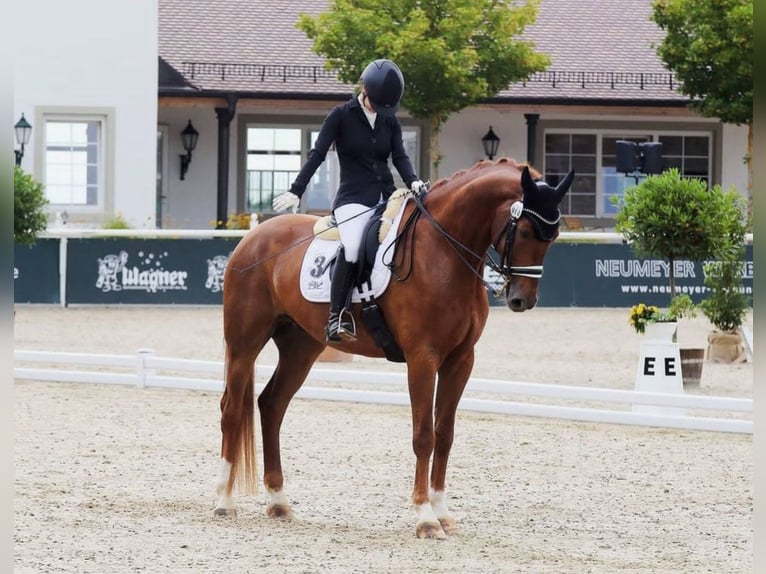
[44,116,105,211]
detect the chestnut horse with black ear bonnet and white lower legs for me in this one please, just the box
[214,158,574,539]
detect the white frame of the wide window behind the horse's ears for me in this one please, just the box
[542,127,715,219]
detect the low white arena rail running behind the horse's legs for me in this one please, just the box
[14,349,753,434]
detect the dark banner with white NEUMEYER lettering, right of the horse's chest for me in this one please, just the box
[485,242,753,307]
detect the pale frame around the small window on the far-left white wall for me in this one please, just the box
[34,107,115,223]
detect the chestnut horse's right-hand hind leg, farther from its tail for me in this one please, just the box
[258,322,324,517]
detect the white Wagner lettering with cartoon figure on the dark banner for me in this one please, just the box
[96,251,188,293]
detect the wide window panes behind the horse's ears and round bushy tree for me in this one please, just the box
[543,129,712,217]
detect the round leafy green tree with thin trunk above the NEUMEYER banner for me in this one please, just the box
[615,168,746,299]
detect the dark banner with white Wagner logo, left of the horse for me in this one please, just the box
[66,238,244,305]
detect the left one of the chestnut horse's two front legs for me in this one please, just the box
[407,361,447,538]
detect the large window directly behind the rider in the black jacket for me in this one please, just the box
[245,124,420,213]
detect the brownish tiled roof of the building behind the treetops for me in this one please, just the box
[159,0,687,103]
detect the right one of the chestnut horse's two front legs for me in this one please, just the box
[430,346,474,534]
